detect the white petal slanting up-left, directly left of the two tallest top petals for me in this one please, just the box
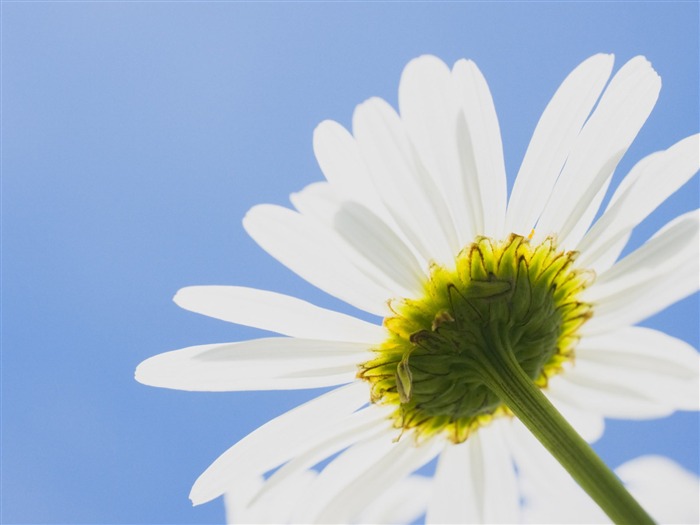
[353,98,456,263]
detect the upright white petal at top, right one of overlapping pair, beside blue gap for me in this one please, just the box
[452,60,506,238]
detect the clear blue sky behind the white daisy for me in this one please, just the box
[0,2,699,524]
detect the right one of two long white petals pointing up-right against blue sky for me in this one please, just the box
[537,57,661,247]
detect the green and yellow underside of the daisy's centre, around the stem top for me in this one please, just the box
[358,234,593,443]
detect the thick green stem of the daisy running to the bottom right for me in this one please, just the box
[479,330,654,525]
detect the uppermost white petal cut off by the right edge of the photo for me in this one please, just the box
[576,135,700,272]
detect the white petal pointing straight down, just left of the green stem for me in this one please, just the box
[426,420,519,524]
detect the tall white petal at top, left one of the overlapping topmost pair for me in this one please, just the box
[399,55,483,248]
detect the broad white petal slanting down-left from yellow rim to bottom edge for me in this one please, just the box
[295,430,438,523]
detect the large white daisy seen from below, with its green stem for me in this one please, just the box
[136,54,700,523]
